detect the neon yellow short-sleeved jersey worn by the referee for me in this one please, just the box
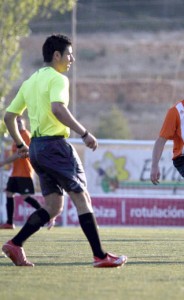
[6,67,70,137]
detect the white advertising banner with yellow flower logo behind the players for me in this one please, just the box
[85,144,182,194]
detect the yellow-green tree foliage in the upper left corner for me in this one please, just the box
[0,0,76,135]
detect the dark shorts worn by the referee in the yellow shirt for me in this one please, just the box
[29,137,86,196]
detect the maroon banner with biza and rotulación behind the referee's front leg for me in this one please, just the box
[66,197,184,226]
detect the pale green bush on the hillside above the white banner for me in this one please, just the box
[96,105,131,139]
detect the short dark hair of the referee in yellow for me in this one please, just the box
[42,34,72,63]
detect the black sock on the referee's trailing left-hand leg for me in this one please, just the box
[12,208,50,247]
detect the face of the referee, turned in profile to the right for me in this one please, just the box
[55,46,75,73]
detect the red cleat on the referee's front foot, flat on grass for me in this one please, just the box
[93,253,127,268]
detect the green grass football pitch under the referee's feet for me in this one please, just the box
[0,227,184,300]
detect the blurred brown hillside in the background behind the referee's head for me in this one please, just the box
[15,0,184,140]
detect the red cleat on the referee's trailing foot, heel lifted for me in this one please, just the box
[2,240,34,267]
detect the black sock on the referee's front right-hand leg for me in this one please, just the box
[79,213,107,258]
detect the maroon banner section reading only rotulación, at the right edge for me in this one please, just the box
[122,198,184,226]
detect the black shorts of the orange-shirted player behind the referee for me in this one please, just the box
[6,177,35,195]
